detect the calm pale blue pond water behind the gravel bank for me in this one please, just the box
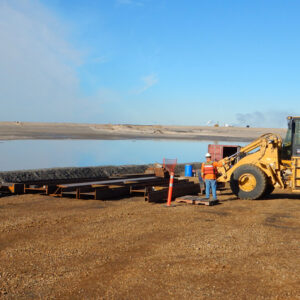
[0,140,241,171]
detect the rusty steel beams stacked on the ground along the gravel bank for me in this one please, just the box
[0,174,200,202]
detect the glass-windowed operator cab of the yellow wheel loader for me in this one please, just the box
[281,117,300,160]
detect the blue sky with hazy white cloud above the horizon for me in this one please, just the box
[0,0,300,127]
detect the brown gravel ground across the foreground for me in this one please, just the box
[0,192,300,299]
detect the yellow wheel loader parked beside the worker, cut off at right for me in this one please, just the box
[217,117,300,200]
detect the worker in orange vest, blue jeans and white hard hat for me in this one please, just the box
[201,153,222,200]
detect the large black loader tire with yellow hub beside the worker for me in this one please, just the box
[230,164,267,200]
